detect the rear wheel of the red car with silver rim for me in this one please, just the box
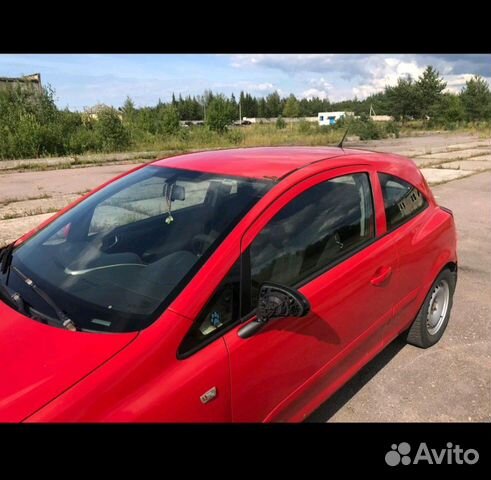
[406,269,456,348]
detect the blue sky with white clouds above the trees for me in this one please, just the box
[0,53,491,110]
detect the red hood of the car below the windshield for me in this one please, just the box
[0,302,138,422]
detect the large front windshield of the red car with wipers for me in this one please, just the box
[0,166,271,332]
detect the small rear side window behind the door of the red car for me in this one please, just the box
[378,173,428,230]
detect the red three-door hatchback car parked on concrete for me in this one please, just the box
[0,147,457,422]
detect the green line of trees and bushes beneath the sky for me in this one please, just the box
[0,66,491,159]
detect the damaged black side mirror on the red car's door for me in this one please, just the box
[239,282,310,338]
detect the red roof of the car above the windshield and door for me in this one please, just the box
[151,147,410,179]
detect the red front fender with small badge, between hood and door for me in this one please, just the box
[27,310,231,422]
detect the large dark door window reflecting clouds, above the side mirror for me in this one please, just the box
[250,173,375,306]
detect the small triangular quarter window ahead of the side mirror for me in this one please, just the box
[179,259,240,355]
